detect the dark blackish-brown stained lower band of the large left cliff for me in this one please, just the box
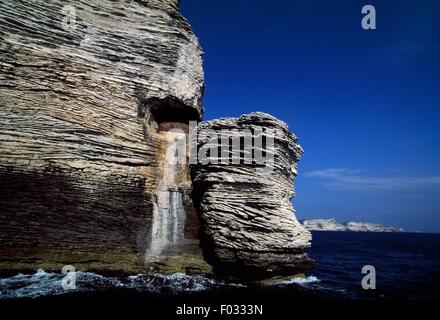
[0,166,152,271]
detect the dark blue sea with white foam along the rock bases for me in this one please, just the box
[0,232,440,301]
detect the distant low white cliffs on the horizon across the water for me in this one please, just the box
[300,219,405,232]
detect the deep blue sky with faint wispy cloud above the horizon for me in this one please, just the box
[181,0,440,232]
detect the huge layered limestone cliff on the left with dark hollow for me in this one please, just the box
[0,0,204,270]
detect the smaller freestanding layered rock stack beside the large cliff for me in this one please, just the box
[191,113,313,277]
